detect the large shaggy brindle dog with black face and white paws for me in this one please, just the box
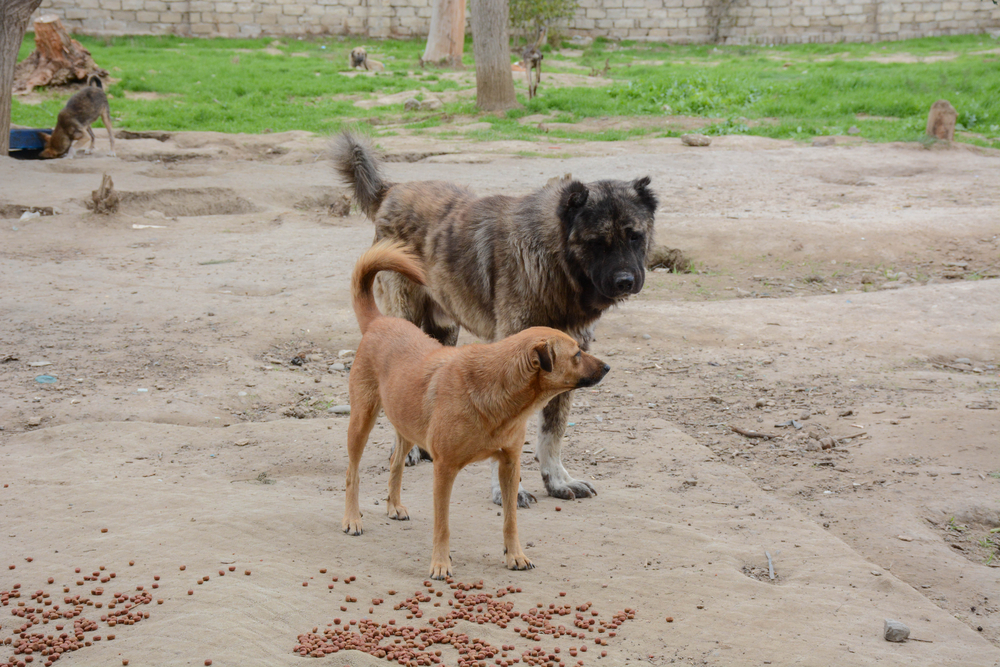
[333,132,657,507]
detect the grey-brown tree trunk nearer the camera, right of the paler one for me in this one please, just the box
[472,0,517,111]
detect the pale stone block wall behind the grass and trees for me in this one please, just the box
[31,0,1000,44]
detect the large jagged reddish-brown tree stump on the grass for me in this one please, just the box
[14,14,108,95]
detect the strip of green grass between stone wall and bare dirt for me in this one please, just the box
[13,35,1000,147]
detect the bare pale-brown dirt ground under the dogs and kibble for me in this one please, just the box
[0,130,1000,666]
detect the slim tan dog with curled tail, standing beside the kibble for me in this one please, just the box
[343,242,609,579]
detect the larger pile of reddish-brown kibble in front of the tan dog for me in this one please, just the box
[293,578,635,667]
